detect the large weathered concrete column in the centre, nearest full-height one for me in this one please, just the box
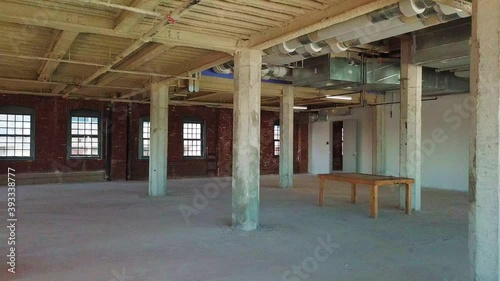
[232,49,262,231]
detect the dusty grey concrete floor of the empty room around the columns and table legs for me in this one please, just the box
[0,175,468,281]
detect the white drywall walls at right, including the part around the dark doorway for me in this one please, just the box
[309,93,470,191]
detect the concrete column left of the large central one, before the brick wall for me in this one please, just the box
[149,83,169,196]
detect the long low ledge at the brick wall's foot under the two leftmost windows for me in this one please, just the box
[0,171,106,186]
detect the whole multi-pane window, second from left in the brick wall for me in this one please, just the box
[68,110,101,158]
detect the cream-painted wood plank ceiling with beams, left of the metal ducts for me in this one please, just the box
[0,0,406,107]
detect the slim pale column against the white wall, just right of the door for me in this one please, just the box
[372,95,385,175]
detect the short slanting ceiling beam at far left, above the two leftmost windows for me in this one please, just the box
[38,31,78,81]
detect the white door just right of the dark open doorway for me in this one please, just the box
[343,119,358,173]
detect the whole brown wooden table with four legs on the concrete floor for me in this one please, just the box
[318,173,415,218]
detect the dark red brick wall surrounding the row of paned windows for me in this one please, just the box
[0,95,308,180]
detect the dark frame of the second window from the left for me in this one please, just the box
[66,109,103,160]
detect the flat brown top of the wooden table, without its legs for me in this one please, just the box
[318,173,414,185]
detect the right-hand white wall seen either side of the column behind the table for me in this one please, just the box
[385,94,470,191]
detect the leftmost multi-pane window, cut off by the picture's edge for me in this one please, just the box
[0,106,35,159]
